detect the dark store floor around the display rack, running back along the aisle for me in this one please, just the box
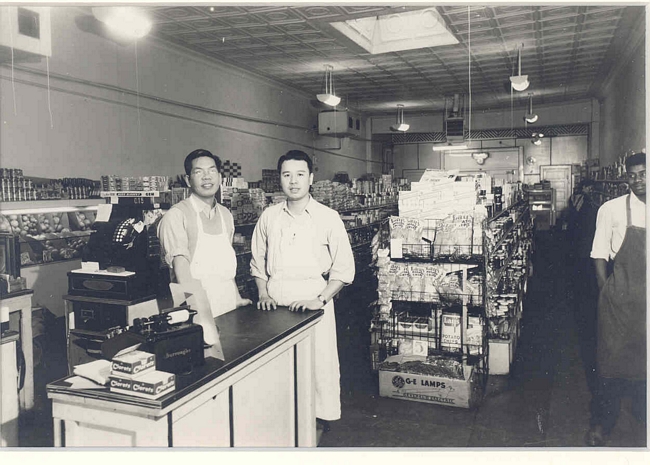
[320,231,646,448]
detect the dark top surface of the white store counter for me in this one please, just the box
[47,305,323,409]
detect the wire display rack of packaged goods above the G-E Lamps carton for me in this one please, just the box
[371,201,532,398]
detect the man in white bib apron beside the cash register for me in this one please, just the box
[158,149,251,317]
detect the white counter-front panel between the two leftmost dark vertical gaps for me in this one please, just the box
[172,390,230,447]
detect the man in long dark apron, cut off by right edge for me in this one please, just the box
[586,153,647,446]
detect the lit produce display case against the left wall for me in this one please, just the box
[0,199,104,268]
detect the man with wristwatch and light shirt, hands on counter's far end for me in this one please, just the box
[251,150,355,431]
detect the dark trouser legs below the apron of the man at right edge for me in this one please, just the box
[590,377,647,434]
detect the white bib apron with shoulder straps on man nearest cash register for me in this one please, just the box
[190,208,237,317]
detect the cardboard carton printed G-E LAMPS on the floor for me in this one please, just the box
[379,355,480,408]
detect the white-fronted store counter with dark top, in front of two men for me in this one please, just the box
[47,305,323,447]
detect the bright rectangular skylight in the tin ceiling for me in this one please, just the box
[330,8,458,55]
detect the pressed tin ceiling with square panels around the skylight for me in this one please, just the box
[139,3,645,114]
